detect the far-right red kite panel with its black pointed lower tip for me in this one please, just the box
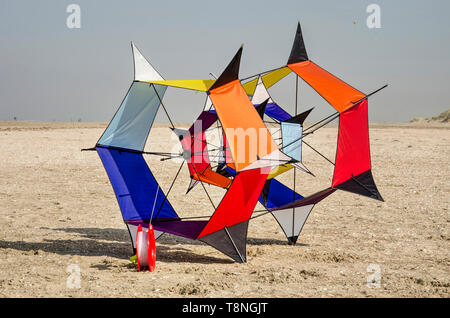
[332,100,383,201]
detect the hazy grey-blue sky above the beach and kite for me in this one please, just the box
[0,0,450,122]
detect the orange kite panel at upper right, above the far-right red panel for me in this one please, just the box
[288,61,366,113]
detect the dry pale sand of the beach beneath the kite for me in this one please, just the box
[0,122,450,297]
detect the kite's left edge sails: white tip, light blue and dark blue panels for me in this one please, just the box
[95,43,174,250]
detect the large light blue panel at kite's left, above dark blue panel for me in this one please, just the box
[97,82,167,151]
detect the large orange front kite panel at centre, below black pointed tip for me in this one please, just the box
[209,80,278,171]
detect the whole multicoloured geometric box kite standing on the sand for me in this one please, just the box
[82,23,382,262]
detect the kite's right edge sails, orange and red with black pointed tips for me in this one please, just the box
[287,23,383,201]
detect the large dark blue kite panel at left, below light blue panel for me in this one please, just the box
[97,147,178,221]
